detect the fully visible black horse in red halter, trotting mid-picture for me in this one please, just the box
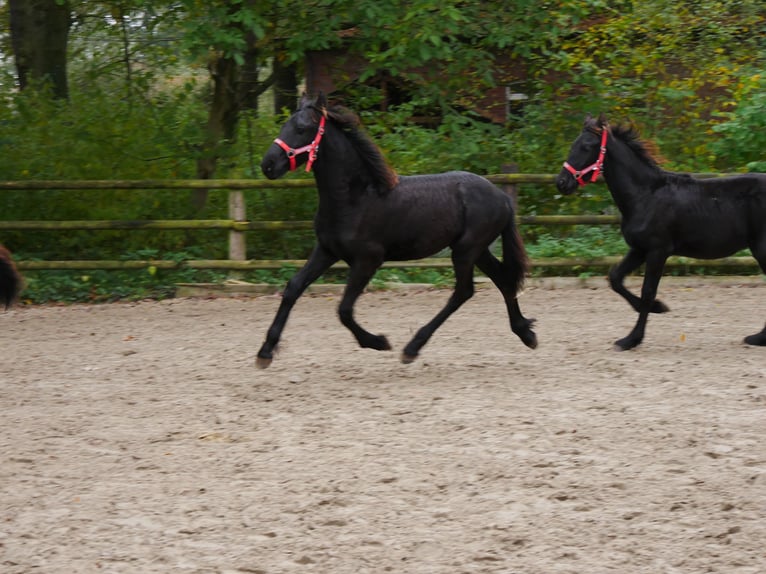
[257,95,537,368]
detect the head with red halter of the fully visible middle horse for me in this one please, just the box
[261,94,327,179]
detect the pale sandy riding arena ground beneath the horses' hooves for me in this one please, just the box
[0,281,766,574]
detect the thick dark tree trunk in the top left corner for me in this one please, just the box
[8,0,71,99]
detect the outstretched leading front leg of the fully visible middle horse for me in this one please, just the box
[255,244,338,369]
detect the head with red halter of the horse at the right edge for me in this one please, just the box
[556,114,609,195]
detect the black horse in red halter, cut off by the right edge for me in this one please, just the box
[556,115,766,349]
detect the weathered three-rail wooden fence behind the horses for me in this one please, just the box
[0,173,758,271]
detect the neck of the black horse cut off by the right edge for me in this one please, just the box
[604,140,663,216]
